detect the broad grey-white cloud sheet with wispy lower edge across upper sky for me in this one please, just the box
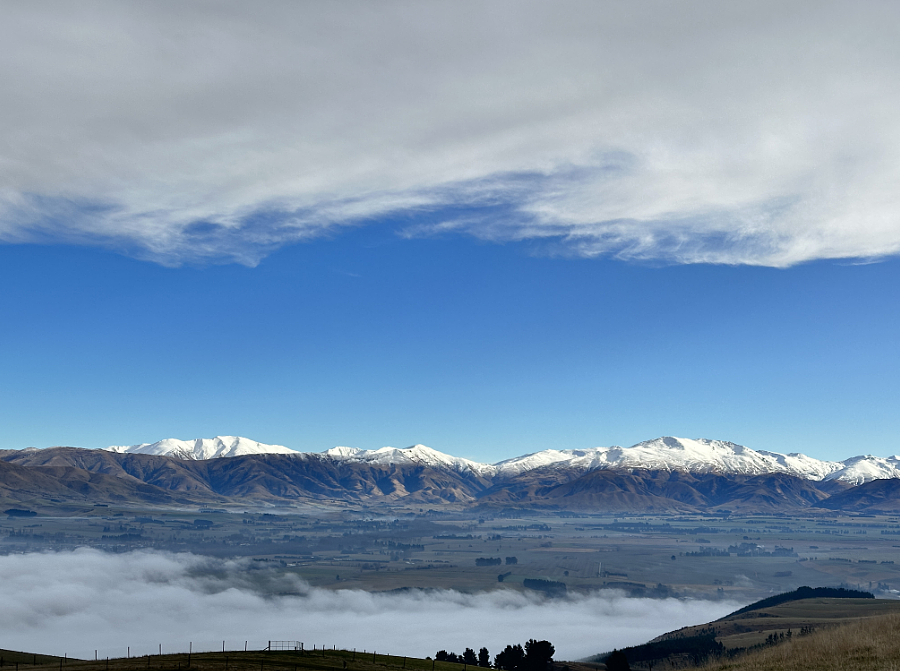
[0,2,900,267]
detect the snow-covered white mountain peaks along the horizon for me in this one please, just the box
[106,436,900,485]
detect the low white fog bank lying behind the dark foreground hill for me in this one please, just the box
[0,549,742,659]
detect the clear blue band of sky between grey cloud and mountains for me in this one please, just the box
[0,221,900,461]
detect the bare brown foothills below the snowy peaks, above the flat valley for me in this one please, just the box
[0,447,900,514]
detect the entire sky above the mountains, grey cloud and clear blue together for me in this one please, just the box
[0,0,900,461]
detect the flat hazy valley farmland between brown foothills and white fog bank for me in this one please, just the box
[0,505,900,602]
